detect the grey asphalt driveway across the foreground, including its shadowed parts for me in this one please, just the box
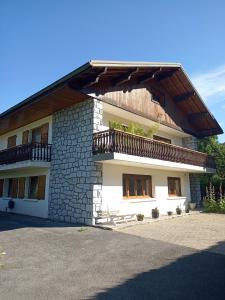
[0,214,225,300]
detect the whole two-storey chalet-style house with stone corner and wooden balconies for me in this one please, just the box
[0,61,223,224]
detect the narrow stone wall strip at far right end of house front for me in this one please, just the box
[183,137,201,206]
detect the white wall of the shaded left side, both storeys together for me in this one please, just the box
[0,116,52,218]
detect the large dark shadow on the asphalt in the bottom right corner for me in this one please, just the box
[89,242,225,300]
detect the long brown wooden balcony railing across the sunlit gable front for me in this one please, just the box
[93,129,216,169]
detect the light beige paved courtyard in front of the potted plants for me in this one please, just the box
[120,213,225,254]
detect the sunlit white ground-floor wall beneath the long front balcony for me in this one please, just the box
[102,164,190,216]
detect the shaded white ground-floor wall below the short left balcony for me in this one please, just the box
[0,168,49,218]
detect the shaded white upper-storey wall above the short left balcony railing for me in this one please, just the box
[0,116,52,150]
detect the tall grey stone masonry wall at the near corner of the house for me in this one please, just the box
[49,100,102,225]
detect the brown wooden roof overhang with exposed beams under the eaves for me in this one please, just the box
[0,61,223,137]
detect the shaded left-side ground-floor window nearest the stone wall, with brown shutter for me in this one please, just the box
[28,175,46,200]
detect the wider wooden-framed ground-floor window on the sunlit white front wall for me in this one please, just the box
[123,174,152,198]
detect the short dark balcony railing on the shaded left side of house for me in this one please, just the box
[0,143,51,165]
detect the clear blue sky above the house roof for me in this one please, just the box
[0,0,225,142]
